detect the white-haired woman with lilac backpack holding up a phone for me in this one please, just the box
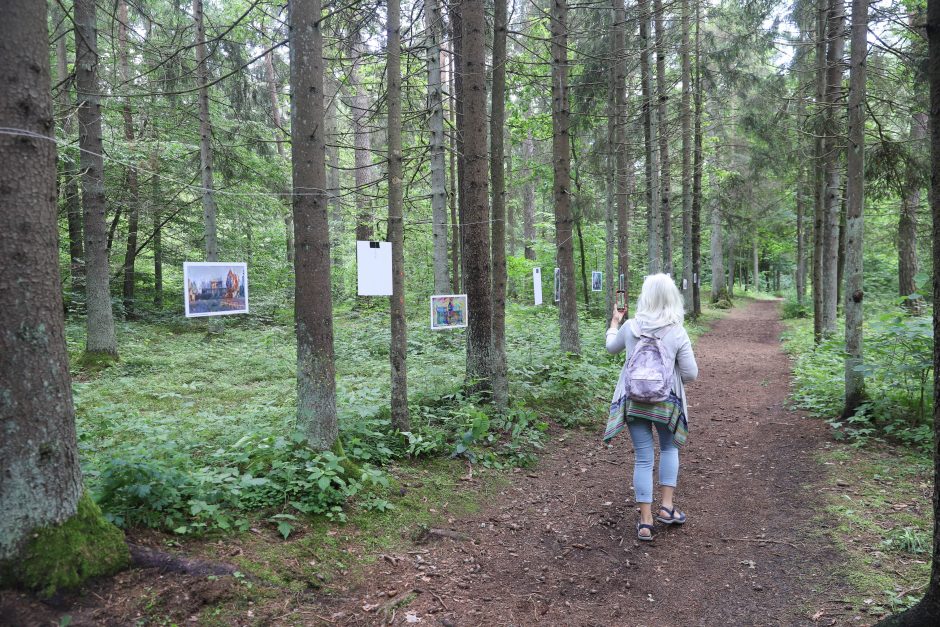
[604,274,698,541]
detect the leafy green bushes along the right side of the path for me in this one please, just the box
[783,302,934,451]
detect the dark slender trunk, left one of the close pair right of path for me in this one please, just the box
[813,0,829,342]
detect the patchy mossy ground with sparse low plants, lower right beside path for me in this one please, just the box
[818,443,933,617]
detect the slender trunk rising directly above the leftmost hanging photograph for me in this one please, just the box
[193,0,219,261]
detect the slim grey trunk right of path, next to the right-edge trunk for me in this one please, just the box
[843,0,868,416]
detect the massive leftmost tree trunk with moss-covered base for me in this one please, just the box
[0,0,128,596]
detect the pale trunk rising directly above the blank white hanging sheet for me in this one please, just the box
[349,33,375,241]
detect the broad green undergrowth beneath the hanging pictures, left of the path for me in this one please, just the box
[67,305,715,540]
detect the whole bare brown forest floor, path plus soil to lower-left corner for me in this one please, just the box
[0,301,924,626]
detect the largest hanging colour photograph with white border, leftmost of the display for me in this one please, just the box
[183,261,248,318]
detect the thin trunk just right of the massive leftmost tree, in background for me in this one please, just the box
[56,7,85,294]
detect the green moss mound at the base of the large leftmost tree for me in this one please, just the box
[0,492,130,597]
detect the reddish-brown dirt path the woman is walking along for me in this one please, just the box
[314,301,844,626]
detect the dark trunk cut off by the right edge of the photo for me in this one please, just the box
[878,0,940,627]
